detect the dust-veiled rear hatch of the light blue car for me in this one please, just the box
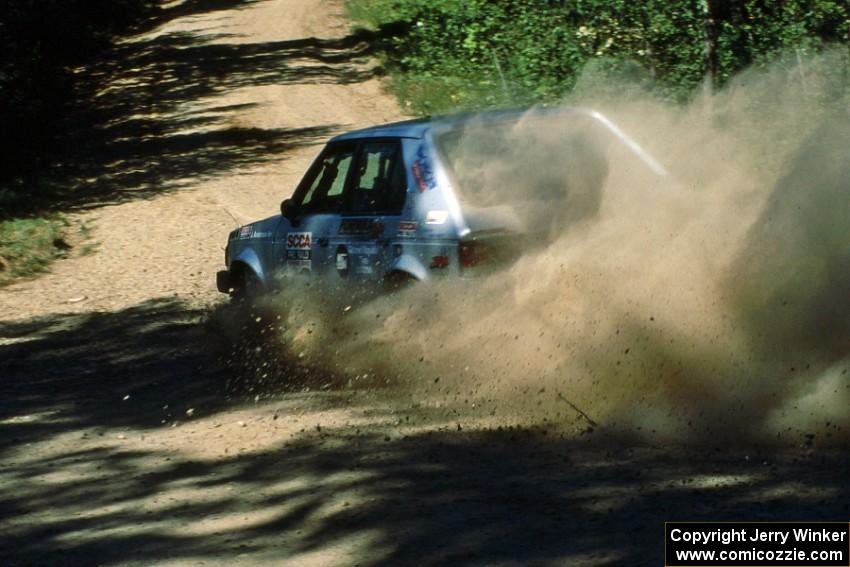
[433,111,607,268]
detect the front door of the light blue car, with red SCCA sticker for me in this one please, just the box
[275,142,356,275]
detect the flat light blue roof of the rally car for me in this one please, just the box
[330,106,578,142]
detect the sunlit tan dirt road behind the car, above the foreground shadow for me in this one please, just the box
[0,0,402,320]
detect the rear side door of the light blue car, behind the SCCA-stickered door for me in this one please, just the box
[331,138,407,282]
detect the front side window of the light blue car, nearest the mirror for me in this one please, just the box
[299,144,354,214]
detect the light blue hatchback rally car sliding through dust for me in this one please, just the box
[217,108,660,296]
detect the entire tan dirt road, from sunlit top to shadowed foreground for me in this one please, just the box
[0,0,850,567]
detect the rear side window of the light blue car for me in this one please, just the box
[347,141,407,213]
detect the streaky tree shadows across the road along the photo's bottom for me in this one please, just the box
[0,414,850,567]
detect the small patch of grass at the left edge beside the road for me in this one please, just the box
[0,216,70,286]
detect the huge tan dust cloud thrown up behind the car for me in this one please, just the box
[255,50,850,445]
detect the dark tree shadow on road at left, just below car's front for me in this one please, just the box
[0,298,376,456]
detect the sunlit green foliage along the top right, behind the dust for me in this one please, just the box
[348,0,850,114]
